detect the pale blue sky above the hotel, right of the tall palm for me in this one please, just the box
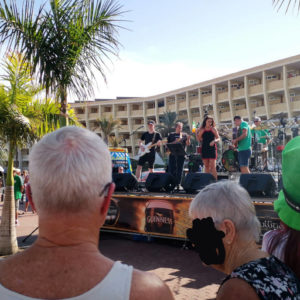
[2,0,300,100]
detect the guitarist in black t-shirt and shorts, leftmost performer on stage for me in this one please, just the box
[135,120,162,181]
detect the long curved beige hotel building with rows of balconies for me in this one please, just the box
[71,55,300,155]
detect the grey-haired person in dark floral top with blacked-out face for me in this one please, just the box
[187,181,300,300]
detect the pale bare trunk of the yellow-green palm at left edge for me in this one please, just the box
[0,142,19,255]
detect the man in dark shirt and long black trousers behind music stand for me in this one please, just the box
[168,122,191,184]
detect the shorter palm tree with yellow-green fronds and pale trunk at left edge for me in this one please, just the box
[0,55,66,255]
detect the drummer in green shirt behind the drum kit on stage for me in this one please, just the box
[251,117,271,170]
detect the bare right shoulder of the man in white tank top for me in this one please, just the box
[130,269,174,300]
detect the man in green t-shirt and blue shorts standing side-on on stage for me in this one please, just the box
[232,116,252,174]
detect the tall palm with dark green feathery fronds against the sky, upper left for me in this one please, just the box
[0,0,123,123]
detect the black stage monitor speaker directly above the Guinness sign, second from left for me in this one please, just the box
[146,173,176,193]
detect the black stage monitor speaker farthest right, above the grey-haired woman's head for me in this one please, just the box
[240,173,276,197]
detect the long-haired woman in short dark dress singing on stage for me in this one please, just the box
[196,116,220,179]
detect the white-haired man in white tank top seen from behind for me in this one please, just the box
[0,127,173,300]
